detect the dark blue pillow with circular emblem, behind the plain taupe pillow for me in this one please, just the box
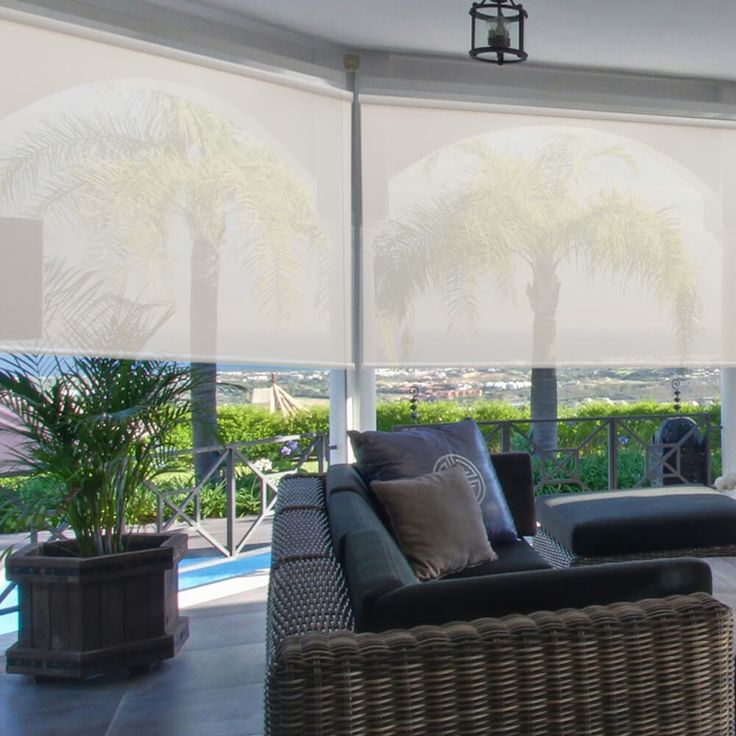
[348,419,518,545]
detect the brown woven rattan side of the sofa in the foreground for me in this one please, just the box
[268,593,734,736]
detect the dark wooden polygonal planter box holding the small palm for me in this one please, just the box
[5,534,189,678]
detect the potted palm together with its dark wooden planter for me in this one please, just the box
[0,356,191,678]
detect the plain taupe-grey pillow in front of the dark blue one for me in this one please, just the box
[371,466,498,580]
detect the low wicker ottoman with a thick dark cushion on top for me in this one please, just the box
[534,485,736,567]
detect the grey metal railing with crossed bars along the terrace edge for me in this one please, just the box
[0,413,720,568]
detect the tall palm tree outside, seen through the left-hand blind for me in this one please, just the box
[0,84,325,479]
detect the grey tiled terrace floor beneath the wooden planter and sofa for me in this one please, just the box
[0,529,736,736]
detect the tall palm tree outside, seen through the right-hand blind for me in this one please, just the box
[375,135,699,450]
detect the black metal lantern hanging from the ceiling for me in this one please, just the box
[470,0,527,64]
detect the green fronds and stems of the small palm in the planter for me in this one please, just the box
[0,355,190,557]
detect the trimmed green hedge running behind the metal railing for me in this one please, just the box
[0,401,720,532]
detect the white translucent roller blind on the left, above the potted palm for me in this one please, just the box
[0,14,351,367]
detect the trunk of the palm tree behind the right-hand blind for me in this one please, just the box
[527,252,560,452]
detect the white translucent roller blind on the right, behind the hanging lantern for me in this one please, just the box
[362,97,736,366]
